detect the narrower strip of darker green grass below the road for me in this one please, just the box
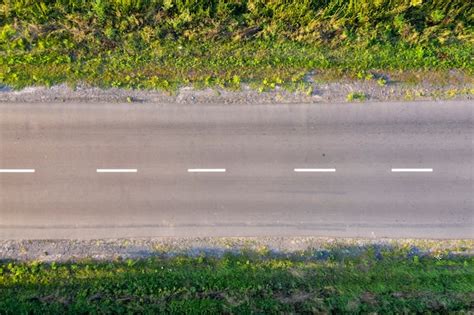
[0,246,474,314]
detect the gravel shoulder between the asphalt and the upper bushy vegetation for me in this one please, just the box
[0,79,474,105]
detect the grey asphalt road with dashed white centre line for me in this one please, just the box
[0,102,474,239]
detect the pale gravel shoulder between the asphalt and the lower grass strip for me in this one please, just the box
[0,237,474,262]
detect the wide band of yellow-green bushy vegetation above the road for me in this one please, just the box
[0,0,474,91]
